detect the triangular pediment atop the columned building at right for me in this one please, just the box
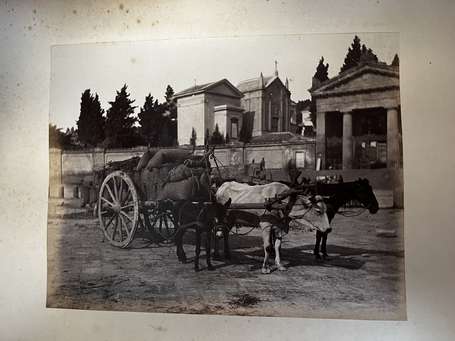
[310,64,399,98]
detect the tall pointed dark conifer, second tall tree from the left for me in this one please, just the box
[105,84,138,147]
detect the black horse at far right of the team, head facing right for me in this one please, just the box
[314,178,379,260]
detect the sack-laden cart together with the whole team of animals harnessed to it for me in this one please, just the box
[97,145,378,273]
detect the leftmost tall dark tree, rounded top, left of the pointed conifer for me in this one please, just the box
[77,89,105,146]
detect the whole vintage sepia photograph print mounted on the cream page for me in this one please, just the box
[47,32,407,320]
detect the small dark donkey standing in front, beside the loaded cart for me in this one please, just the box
[175,200,231,271]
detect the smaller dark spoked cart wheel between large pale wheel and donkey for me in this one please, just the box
[144,202,178,242]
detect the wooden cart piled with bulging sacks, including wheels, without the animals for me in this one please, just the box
[97,149,214,248]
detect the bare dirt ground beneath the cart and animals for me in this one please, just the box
[47,200,406,319]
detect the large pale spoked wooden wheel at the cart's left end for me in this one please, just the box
[98,171,139,248]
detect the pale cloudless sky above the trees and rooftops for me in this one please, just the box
[50,33,399,129]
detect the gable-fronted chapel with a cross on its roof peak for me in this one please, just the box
[237,70,291,136]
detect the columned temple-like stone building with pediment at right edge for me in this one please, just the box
[309,62,402,169]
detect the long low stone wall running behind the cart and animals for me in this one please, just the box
[49,142,403,207]
